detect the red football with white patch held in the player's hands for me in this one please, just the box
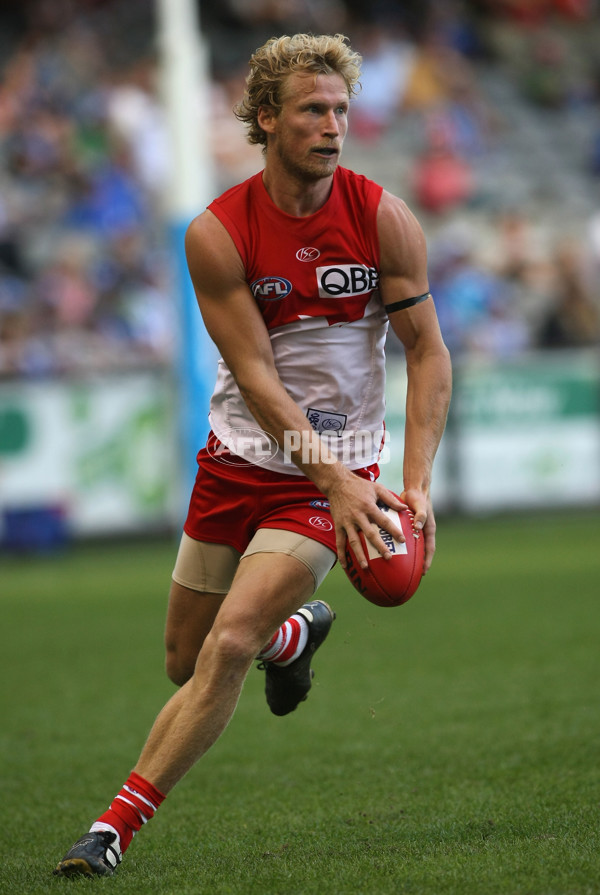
[345,505,425,606]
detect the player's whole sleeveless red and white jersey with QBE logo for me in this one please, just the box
[209,167,387,474]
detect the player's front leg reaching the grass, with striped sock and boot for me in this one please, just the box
[55,553,314,875]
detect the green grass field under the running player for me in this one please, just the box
[0,513,600,895]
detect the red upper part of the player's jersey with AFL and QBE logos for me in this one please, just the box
[208,168,382,329]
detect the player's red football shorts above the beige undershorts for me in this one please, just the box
[183,433,379,553]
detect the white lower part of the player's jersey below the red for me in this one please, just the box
[209,293,388,475]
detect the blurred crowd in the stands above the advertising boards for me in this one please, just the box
[0,0,600,378]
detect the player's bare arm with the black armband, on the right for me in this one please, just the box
[378,192,452,571]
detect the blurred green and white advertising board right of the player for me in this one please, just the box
[382,352,600,513]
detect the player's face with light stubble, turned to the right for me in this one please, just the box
[259,74,349,181]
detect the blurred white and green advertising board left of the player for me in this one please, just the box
[0,373,177,535]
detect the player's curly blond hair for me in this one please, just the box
[233,34,362,146]
